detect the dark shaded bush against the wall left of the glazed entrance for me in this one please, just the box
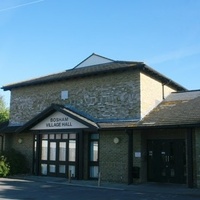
[2,149,28,175]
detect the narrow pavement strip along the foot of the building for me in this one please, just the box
[8,175,200,198]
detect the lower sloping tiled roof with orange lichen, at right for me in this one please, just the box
[138,90,200,127]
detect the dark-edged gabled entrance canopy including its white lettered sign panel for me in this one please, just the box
[17,104,99,132]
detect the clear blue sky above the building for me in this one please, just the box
[0,0,200,104]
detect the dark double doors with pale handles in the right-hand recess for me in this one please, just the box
[147,140,186,184]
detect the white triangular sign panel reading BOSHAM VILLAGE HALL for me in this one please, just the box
[31,111,88,130]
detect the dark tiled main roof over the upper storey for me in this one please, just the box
[2,53,186,91]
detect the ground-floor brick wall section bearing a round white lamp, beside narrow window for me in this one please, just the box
[99,131,128,183]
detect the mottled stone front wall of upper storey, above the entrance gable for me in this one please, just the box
[10,71,140,124]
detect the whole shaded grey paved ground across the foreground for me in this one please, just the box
[0,176,200,200]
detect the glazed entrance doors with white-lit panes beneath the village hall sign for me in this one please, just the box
[40,133,77,177]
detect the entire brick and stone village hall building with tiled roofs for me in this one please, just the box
[0,54,200,187]
